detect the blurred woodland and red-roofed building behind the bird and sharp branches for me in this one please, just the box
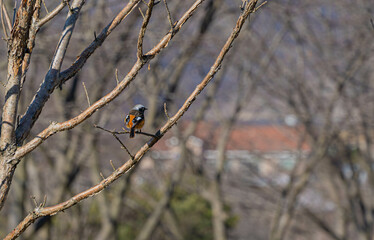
[0,0,374,240]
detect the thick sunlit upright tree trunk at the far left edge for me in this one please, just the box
[0,0,40,212]
